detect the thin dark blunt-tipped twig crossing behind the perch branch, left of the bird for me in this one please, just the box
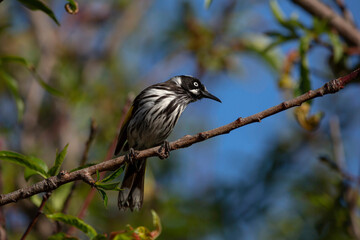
[61,119,97,213]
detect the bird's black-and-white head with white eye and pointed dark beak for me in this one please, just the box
[173,75,221,102]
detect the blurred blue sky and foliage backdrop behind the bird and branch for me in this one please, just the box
[0,0,360,239]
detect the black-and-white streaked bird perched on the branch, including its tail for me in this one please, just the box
[114,75,221,211]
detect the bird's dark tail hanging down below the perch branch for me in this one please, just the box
[118,158,146,211]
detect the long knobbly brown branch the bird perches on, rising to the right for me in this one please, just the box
[0,68,360,206]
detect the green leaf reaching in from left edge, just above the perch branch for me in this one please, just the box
[0,151,49,178]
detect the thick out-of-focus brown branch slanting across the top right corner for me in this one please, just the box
[292,0,360,46]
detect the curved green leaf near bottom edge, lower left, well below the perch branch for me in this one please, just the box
[46,213,97,238]
